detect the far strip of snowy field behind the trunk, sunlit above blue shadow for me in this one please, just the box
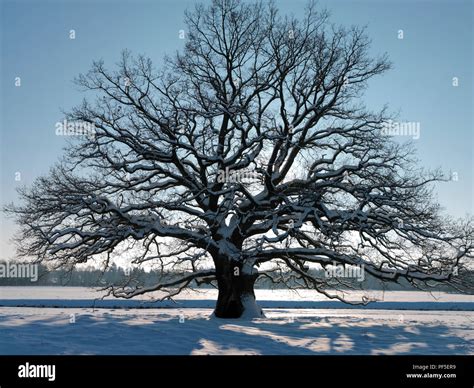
[0,287,474,311]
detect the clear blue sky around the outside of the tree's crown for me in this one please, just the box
[0,0,474,260]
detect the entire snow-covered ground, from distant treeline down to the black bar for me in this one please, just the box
[0,287,474,355]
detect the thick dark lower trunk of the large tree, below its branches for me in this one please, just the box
[214,261,264,319]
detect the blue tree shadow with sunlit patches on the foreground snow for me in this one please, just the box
[0,309,472,355]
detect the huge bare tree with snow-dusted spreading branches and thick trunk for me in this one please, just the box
[7,0,473,318]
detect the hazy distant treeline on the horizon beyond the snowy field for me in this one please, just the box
[0,264,474,292]
